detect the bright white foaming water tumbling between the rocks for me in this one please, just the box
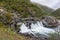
[20,22,55,36]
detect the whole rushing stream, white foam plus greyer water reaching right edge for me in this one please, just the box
[19,21,60,37]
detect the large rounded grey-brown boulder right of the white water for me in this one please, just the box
[42,16,59,28]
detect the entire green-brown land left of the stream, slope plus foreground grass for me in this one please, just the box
[0,0,58,40]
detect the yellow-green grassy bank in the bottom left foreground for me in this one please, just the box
[0,23,29,40]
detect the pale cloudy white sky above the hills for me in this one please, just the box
[31,0,60,10]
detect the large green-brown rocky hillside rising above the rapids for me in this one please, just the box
[0,0,48,25]
